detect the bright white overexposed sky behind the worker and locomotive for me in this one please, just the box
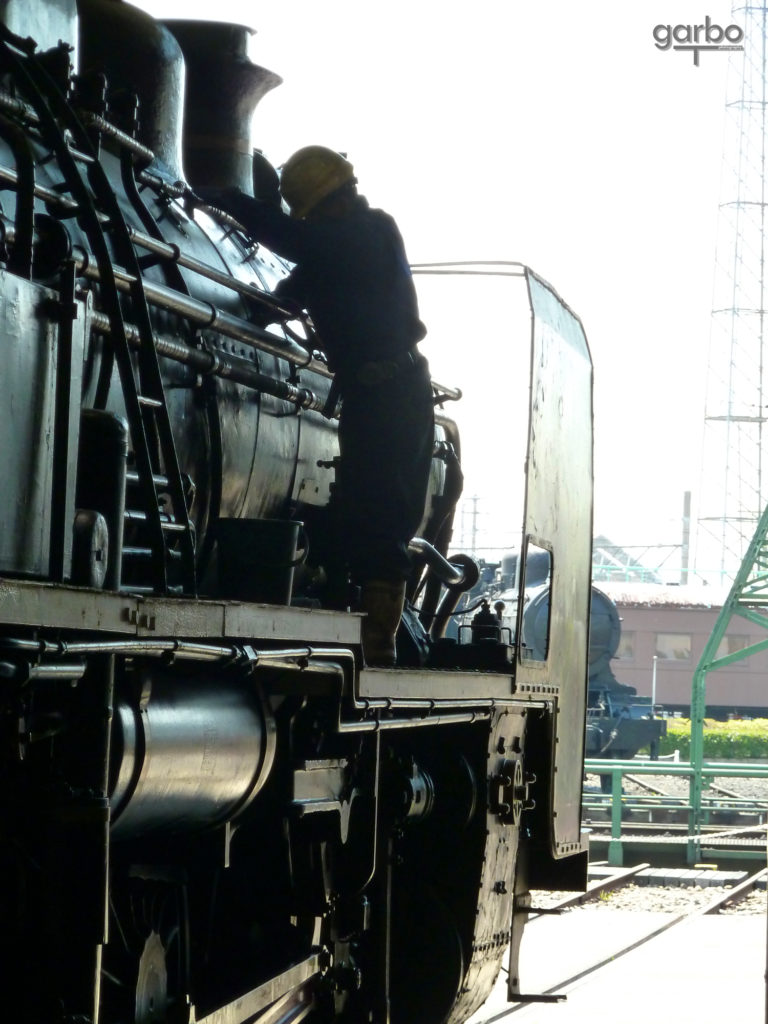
[134,0,732,573]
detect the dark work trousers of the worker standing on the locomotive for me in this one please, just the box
[334,356,434,583]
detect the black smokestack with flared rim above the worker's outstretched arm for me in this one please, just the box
[165,20,283,194]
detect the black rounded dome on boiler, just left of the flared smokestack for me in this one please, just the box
[78,0,184,179]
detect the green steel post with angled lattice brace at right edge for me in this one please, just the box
[688,508,768,863]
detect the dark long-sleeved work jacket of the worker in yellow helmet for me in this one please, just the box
[215,193,426,382]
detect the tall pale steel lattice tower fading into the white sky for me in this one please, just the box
[695,3,768,583]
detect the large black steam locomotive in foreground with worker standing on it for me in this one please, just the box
[0,0,592,1024]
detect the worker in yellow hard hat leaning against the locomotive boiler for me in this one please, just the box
[201,145,434,666]
